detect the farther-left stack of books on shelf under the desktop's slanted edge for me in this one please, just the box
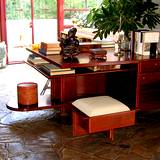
[27,54,49,65]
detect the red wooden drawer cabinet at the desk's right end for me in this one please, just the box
[136,56,160,110]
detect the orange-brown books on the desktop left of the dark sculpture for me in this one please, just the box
[39,42,61,55]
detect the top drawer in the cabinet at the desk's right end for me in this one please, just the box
[139,60,160,73]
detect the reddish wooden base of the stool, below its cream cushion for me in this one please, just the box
[72,107,135,140]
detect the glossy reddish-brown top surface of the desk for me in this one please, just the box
[27,48,160,68]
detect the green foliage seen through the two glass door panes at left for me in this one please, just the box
[6,0,57,20]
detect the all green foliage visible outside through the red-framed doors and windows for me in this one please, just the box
[6,0,102,20]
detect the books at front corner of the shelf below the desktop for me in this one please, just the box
[40,63,75,76]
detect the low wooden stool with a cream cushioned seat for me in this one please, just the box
[72,96,135,140]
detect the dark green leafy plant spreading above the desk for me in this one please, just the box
[85,0,160,39]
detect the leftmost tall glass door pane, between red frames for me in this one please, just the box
[6,0,32,62]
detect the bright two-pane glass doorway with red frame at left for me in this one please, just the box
[6,0,57,63]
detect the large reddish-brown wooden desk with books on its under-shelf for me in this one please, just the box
[8,48,160,113]
